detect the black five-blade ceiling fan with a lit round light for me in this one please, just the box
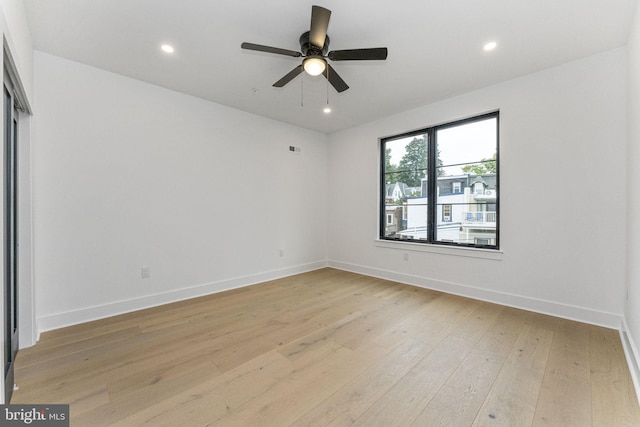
[240,6,387,92]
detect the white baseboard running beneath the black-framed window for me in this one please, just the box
[329,260,622,330]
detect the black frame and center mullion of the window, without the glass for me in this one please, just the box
[378,110,500,250]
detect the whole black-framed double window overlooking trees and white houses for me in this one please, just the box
[380,112,500,249]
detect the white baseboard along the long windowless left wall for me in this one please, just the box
[37,261,327,339]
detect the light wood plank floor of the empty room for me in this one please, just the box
[12,269,640,427]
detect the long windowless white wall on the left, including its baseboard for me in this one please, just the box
[33,51,327,330]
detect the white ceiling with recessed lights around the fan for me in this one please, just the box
[25,0,638,133]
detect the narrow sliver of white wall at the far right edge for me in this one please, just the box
[623,1,640,399]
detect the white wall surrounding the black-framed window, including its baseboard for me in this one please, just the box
[328,48,626,328]
